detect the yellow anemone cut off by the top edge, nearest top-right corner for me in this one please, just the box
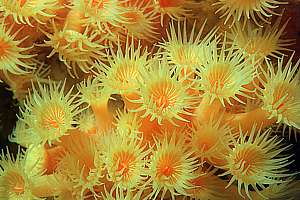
[214,0,287,26]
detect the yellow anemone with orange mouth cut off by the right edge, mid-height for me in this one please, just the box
[257,56,300,129]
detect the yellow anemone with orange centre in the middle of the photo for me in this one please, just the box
[130,58,196,125]
